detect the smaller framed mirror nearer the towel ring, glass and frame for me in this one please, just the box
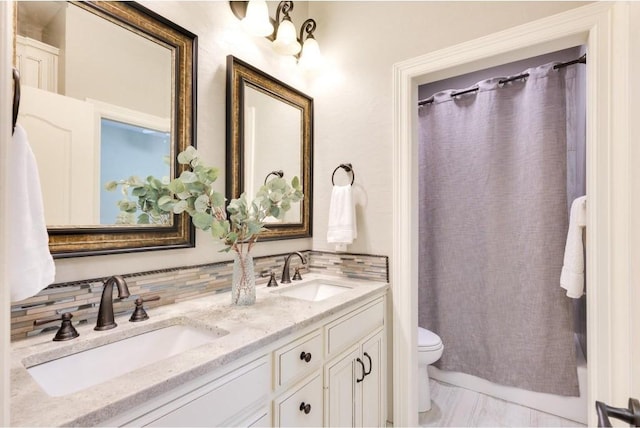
[226,55,313,240]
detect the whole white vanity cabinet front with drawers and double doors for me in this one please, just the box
[99,294,386,427]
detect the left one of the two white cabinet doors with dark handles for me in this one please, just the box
[326,346,364,427]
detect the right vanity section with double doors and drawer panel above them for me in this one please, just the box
[325,301,386,427]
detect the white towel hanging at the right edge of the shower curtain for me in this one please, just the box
[560,196,587,299]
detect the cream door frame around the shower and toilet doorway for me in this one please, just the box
[391,2,633,426]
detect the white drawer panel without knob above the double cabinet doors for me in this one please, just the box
[325,299,384,354]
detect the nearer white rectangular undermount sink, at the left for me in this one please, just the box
[27,324,229,397]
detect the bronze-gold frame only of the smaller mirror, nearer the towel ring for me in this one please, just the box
[226,55,313,241]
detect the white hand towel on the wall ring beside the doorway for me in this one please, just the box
[327,185,358,251]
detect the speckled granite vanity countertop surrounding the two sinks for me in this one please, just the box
[11,274,388,426]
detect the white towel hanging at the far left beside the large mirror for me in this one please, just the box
[6,125,56,302]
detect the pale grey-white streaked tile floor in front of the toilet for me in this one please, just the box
[418,379,585,427]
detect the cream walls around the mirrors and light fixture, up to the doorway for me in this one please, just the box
[56,1,583,282]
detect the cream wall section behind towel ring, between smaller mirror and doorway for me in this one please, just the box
[309,1,584,255]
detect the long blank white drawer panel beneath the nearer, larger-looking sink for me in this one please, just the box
[149,358,270,427]
